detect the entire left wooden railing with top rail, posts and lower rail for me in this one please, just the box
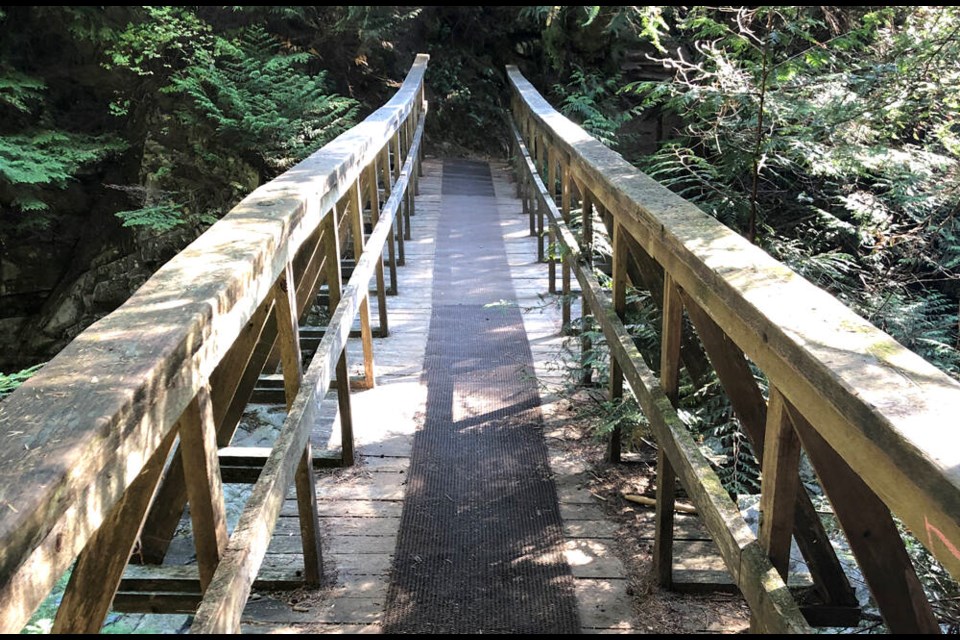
[0,55,427,632]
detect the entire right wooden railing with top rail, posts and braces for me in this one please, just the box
[508,62,960,632]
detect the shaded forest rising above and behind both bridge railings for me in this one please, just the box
[0,6,960,393]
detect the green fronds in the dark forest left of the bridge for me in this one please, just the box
[0,7,357,238]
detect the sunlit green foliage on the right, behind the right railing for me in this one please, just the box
[555,7,960,629]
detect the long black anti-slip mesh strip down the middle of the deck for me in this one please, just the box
[383,160,580,633]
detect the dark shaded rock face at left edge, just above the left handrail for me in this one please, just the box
[0,231,195,371]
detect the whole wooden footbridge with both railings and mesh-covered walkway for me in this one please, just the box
[0,56,960,633]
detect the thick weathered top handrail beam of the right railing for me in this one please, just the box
[508,67,960,575]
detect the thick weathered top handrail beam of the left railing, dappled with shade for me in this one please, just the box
[0,54,428,632]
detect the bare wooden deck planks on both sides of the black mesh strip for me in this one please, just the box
[133,159,736,633]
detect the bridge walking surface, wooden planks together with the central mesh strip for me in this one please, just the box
[221,160,740,633]
